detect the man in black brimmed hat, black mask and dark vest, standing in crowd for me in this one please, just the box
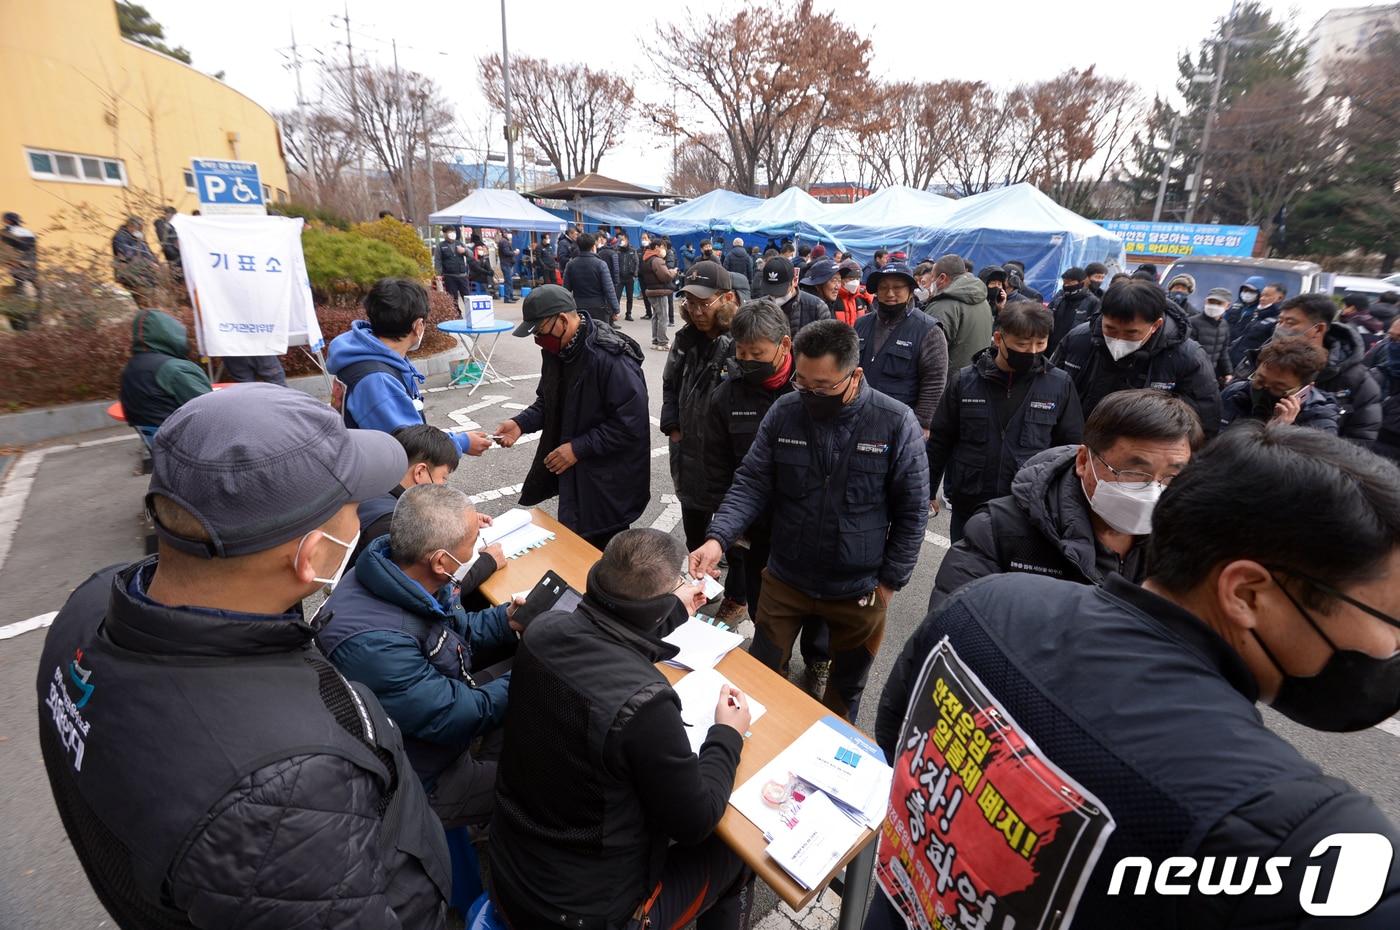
[855,262,952,440]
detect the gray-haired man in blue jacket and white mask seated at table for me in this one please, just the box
[316,485,518,828]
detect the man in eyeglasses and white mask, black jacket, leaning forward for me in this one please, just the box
[928,389,1204,609]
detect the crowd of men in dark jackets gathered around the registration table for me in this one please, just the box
[30,210,1400,929]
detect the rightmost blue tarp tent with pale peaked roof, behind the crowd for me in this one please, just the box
[911,183,1127,296]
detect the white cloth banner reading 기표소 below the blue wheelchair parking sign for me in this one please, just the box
[175,216,322,357]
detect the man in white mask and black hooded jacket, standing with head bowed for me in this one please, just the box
[1050,279,1221,437]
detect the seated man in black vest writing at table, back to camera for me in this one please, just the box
[490,529,752,930]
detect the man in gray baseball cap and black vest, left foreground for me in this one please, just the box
[38,384,451,929]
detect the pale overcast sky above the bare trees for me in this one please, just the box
[143,0,1362,185]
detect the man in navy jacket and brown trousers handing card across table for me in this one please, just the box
[690,319,928,720]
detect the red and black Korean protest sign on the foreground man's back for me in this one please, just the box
[875,637,1113,930]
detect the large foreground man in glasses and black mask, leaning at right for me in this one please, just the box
[867,423,1400,930]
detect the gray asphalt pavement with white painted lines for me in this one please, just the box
[0,304,1400,930]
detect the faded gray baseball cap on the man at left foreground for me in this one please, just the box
[146,384,409,559]
